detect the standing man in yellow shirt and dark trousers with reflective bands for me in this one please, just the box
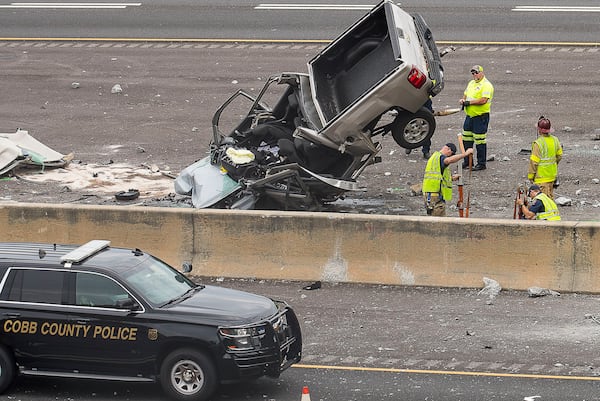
[459,65,494,171]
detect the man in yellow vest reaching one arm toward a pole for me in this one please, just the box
[422,142,473,216]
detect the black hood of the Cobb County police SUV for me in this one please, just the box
[168,285,277,325]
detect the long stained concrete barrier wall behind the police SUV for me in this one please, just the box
[0,204,600,292]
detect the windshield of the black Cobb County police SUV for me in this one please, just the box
[124,257,196,306]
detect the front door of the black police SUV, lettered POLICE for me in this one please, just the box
[63,271,155,377]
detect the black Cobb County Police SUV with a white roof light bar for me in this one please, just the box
[0,240,302,401]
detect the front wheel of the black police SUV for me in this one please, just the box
[160,349,217,401]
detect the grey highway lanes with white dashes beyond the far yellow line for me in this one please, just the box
[0,0,600,45]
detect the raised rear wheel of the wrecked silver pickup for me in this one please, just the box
[392,107,435,149]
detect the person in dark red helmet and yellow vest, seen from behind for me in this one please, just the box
[527,116,562,199]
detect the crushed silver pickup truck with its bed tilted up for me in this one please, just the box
[175,0,444,210]
